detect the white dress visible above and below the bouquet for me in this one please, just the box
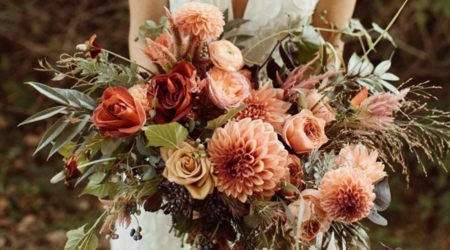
[111,0,319,250]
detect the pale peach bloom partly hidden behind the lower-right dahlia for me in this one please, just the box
[337,144,387,183]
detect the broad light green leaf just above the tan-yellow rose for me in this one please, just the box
[142,122,189,149]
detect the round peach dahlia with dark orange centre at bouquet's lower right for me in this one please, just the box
[319,167,375,222]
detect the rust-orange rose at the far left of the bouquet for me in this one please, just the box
[92,87,146,137]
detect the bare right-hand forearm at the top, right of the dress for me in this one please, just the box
[313,0,356,51]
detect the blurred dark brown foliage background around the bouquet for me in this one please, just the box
[0,0,450,250]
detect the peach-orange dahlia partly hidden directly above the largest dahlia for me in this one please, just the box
[235,82,291,132]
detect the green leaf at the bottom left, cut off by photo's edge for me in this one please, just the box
[64,224,98,250]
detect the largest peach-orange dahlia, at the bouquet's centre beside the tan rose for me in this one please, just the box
[208,118,288,202]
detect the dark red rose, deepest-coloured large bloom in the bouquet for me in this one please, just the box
[147,61,196,124]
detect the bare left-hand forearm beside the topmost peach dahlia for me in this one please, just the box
[128,0,168,68]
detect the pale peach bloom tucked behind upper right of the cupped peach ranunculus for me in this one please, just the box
[306,89,336,124]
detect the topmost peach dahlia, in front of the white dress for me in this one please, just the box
[175,2,225,41]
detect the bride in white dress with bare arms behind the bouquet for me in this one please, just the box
[111,0,356,250]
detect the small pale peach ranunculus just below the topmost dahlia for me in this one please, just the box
[209,40,244,71]
